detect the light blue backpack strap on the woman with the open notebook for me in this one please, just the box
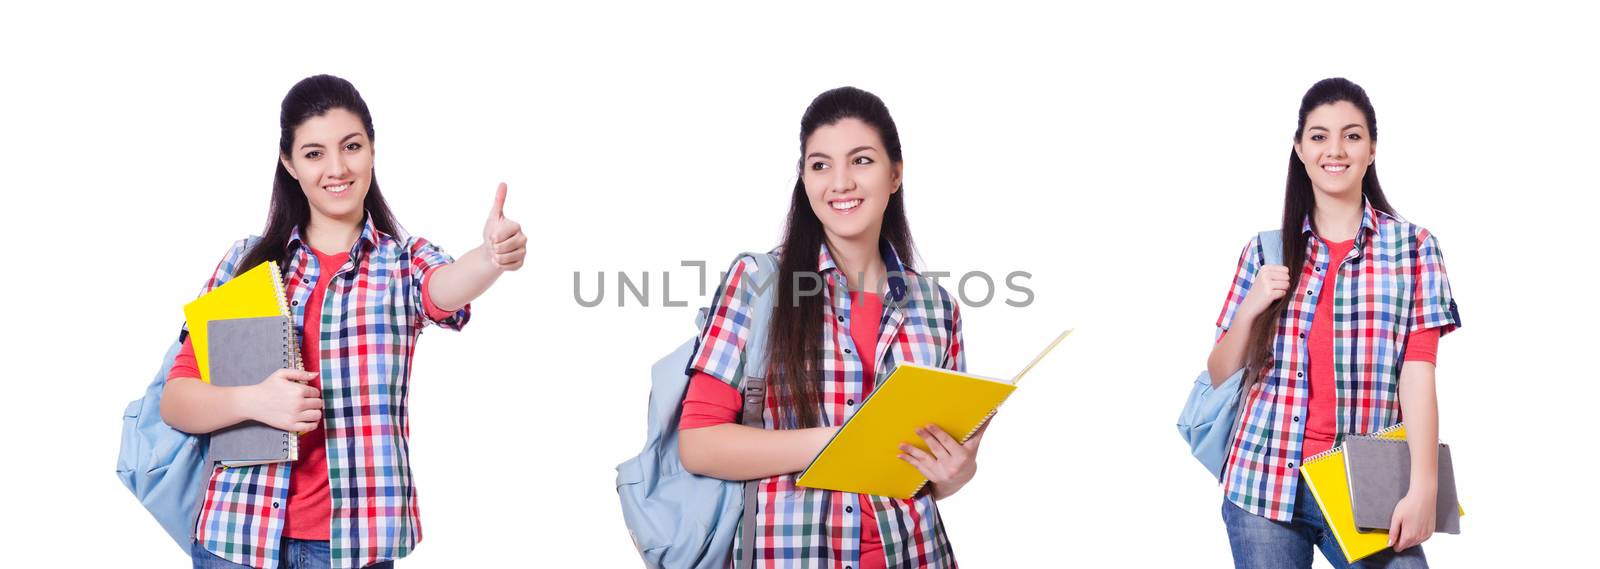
[734,253,778,569]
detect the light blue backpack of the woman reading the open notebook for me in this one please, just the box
[616,253,778,569]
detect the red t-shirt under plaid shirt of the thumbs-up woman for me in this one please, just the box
[166,249,450,540]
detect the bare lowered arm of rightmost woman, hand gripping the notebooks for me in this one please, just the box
[1389,360,1438,551]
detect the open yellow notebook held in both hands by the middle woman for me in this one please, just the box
[795,329,1072,499]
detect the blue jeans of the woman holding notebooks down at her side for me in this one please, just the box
[1222,479,1427,569]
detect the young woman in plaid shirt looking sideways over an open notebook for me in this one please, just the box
[678,86,982,569]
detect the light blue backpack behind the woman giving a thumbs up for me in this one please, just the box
[117,334,210,555]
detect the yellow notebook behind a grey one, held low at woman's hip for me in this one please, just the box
[1301,424,1466,563]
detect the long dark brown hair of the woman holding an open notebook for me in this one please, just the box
[766,86,915,428]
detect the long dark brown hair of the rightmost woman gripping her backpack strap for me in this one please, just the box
[1242,77,1395,393]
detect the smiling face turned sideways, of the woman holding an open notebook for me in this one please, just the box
[802,118,904,246]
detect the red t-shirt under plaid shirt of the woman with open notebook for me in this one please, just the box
[678,291,888,569]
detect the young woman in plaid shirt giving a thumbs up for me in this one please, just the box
[162,75,528,567]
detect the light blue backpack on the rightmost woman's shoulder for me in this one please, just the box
[1178,230,1283,479]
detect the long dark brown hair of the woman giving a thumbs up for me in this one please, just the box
[238,75,402,272]
